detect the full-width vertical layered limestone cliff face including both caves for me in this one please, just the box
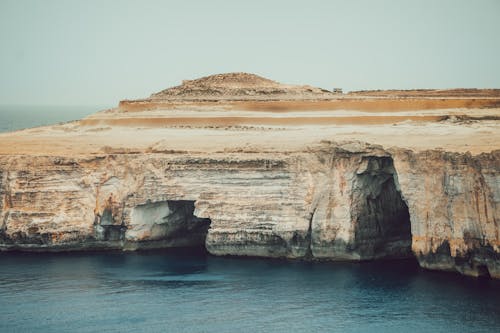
[0,142,500,278]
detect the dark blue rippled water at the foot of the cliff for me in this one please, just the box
[0,252,500,332]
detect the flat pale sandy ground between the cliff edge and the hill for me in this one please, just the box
[0,100,500,155]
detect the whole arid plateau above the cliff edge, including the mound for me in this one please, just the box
[0,73,500,155]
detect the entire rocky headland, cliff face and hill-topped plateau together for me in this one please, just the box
[0,73,500,278]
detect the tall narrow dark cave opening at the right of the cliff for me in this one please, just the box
[353,157,414,260]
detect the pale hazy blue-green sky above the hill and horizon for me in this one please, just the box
[0,0,500,105]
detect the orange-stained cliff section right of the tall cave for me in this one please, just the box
[394,151,500,278]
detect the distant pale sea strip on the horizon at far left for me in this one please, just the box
[0,105,110,133]
